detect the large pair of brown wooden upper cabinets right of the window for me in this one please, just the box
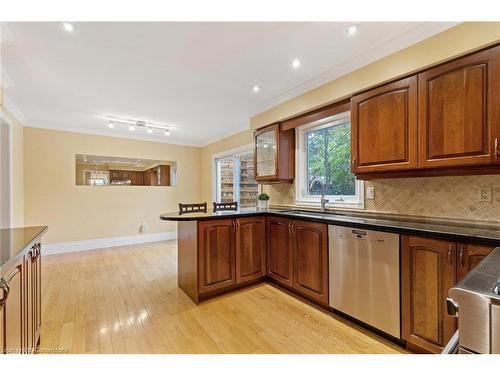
[351,46,500,179]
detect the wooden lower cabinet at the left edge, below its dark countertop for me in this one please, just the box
[0,244,41,354]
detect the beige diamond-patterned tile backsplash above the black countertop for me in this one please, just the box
[265,175,500,223]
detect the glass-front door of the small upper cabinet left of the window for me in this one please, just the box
[255,125,279,179]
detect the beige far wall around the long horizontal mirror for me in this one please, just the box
[24,127,200,243]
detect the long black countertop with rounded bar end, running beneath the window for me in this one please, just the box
[160,208,500,246]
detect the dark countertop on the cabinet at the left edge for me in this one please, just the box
[0,226,47,267]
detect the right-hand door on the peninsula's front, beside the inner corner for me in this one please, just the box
[236,217,266,283]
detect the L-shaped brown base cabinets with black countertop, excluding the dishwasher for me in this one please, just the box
[160,209,500,353]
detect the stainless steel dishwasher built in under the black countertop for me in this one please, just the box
[328,225,401,338]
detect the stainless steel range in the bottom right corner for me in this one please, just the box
[443,248,500,354]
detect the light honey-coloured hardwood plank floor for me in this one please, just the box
[41,241,404,353]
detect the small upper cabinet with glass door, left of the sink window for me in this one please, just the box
[254,124,295,182]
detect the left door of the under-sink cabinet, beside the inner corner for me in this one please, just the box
[267,217,293,286]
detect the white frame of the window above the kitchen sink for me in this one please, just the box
[295,111,365,209]
